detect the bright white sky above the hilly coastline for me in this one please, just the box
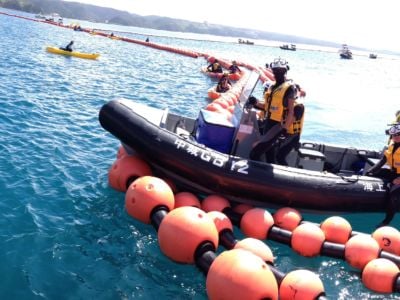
[63,0,400,51]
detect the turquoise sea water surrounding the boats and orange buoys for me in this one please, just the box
[0,10,400,299]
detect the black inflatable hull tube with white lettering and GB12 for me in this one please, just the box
[99,100,387,213]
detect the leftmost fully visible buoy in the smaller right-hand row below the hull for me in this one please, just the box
[240,208,274,240]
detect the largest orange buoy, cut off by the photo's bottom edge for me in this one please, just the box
[206,249,278,300]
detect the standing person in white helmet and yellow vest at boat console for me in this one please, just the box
[249,58,298,163]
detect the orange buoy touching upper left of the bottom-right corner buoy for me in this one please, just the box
[344,234,380,270]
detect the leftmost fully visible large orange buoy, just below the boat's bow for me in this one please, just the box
[125,176,174,224]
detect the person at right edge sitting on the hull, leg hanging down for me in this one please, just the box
[365,122,400,227]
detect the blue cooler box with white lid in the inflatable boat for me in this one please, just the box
[196,109,238,153]
